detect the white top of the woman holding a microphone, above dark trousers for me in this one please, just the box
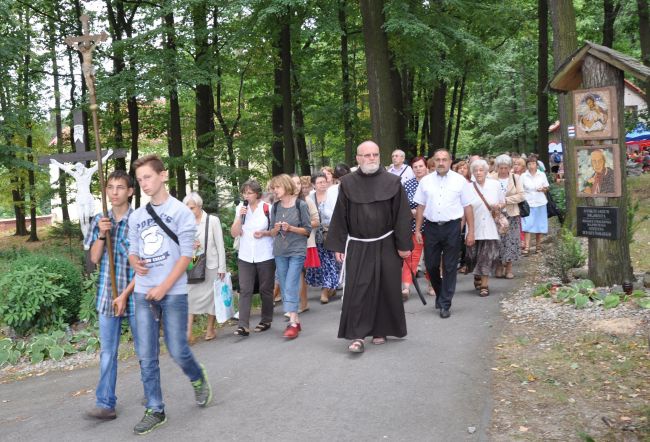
[235,201,273,263]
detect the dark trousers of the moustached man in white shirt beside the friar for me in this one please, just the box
[424,219,462,309]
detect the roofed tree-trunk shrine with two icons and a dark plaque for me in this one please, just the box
[548,41,650,286]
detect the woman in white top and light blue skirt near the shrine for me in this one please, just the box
[521,155,549,256]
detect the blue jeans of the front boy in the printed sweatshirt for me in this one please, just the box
[133,293,203,412]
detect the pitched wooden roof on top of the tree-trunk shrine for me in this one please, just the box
[548,41,650,92]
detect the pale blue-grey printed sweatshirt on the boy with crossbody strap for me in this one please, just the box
[129,195,196,295]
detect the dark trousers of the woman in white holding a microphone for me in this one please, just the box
[237,259,275,330]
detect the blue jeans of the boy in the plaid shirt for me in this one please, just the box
[95,314,138,409]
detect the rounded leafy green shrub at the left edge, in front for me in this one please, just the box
[0,266,69,336]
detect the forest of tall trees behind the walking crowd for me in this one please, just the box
[0,0,650,240]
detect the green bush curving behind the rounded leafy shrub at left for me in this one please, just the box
[12,254,84,323]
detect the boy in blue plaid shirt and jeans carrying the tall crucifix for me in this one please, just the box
[84,170,138,420]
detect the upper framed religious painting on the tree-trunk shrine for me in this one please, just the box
[573,86,618,140]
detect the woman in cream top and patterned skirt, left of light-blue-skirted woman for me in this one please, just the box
[494,155,525,279]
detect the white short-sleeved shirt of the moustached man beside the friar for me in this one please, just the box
[413,170,474,223]
